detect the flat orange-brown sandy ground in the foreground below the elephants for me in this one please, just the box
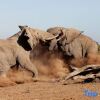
[0,82,100,100]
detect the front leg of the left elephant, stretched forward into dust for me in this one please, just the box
[18,54,38,77]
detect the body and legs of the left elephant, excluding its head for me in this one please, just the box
[0,27,38,77]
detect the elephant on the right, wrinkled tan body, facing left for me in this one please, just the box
[47,27,98,59]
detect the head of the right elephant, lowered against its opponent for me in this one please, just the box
[47,27,83,50]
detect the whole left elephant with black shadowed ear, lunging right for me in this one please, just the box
[5,26,55,77]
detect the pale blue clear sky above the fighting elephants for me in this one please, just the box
[0,0,100,42]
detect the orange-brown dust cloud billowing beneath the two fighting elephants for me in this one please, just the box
[1,45,100,84]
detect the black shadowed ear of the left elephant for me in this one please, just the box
[17,26,32,51]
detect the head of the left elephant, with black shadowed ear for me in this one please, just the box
[17,26,57,51]
